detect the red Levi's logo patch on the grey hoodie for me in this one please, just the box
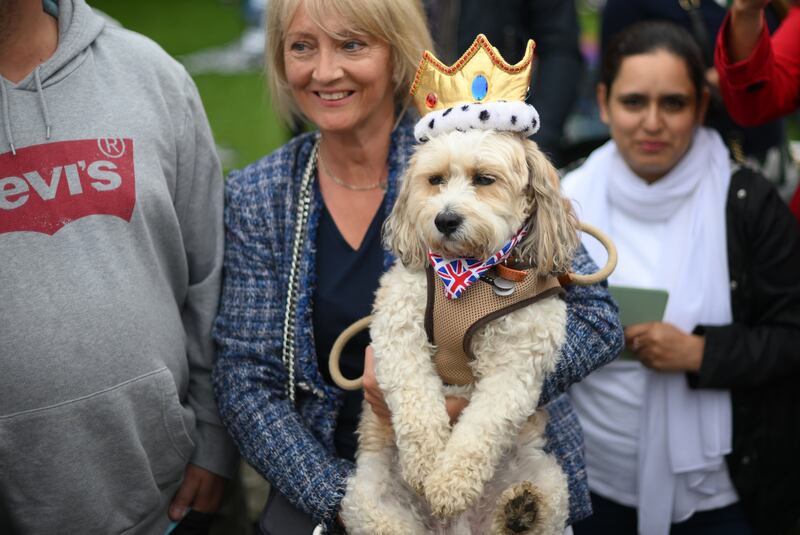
[0,138,136,236]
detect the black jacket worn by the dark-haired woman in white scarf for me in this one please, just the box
[688,168,800,534]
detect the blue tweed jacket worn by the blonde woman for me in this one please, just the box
[214,122,623,525]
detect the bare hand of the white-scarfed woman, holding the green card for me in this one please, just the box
[625,321,705,372]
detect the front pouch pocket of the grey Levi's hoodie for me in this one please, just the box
[0,368,194,533]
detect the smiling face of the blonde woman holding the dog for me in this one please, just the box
[283,2,394,133]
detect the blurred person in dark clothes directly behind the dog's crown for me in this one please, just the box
[429,0,583,167]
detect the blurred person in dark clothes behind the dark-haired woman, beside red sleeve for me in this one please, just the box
[601,0,798,200]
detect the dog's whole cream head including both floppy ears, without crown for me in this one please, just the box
[385,130,577,272]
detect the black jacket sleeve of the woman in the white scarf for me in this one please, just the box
[689,178,800,388]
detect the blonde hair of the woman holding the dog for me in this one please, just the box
[265,0,433,123]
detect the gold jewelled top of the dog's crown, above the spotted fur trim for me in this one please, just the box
[411,34,536,116]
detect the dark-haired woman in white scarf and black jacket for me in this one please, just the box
[564,22,800,535]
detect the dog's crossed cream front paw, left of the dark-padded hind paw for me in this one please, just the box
[424,466,482,519]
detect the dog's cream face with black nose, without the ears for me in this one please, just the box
[405,130,528,258]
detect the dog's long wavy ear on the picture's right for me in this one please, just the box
[518,139,579,275]
